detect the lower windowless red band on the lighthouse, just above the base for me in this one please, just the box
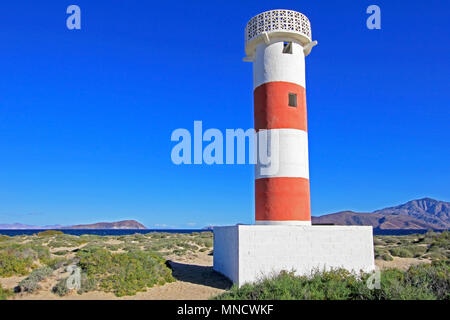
[255,178,311,221]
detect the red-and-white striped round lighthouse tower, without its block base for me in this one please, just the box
[244,10,317,225]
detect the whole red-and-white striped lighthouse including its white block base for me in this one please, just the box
[213,10,375,286]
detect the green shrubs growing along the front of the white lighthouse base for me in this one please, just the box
[216,261,450,300]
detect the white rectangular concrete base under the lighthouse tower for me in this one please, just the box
[214,225,375,286]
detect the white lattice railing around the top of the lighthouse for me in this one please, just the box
[245,10,312,44]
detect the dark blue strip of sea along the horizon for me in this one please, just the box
[0,229,442,236]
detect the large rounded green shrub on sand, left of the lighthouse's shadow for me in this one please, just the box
[77,249,174,296]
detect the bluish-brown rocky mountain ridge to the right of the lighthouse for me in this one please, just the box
[312,198,450,230]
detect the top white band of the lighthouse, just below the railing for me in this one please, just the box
[253,39,306,89]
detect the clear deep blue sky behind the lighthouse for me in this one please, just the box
[0,0,450,228]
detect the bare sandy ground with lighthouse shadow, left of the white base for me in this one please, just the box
[4,252,231,300]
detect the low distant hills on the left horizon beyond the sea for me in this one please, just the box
[0,220,147,230]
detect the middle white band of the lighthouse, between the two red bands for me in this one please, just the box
[255,129,309,179]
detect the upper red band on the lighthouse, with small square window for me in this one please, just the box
[253,81,307,131]
